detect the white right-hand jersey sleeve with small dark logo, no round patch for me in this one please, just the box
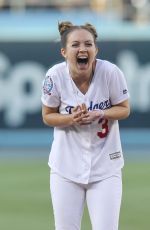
[109,66,129,105]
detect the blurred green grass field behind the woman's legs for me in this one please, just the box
[0,157,150,230]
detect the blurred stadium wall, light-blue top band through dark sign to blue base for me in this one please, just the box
[0,1,150,150]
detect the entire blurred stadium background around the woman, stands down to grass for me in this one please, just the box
[0,0,150,230]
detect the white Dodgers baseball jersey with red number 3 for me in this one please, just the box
[41,59,129,184]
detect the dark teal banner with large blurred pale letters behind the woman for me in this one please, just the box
[0,41,150,129]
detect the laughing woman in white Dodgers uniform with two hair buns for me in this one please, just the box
[42,22,130,230]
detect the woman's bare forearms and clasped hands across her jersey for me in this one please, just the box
[42,100,130,127]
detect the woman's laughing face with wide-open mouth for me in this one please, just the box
[61,29,98,76]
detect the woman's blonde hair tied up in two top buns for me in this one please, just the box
[58,21,98,48]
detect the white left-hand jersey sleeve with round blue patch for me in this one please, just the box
[41,74,60,107]
